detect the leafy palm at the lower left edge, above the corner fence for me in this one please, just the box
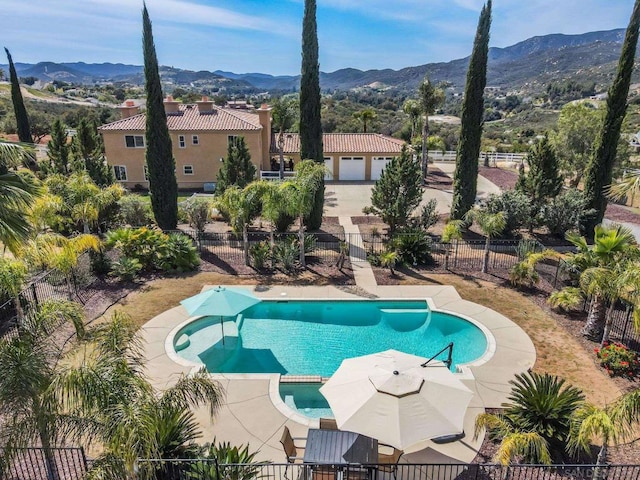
[0,300,83,480]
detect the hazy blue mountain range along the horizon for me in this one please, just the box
[0,29,624,93]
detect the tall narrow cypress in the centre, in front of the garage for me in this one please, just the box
[300,0,324,230]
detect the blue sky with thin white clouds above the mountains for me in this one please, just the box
[0,0,634,74]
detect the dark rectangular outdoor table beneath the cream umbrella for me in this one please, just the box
[303,428,378,478]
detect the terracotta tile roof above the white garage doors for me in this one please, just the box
[271,133,405,155]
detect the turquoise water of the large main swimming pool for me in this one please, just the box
[174,300,487,377]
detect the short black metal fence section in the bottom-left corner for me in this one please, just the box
[0,447,88,480]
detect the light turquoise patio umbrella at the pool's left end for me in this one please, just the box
[180,286,261,345]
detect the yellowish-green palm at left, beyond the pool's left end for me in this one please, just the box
[18,233,100,300]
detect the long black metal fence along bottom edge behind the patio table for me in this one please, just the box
[132,459,640,480]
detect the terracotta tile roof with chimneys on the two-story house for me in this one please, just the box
[99,105,262,131]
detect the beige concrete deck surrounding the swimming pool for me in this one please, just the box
[140,285,536,463]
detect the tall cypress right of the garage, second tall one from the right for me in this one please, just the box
[451,0,491,220]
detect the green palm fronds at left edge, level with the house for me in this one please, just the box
[0,141,41,253]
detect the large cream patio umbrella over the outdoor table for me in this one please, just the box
[320,350,473,450]
